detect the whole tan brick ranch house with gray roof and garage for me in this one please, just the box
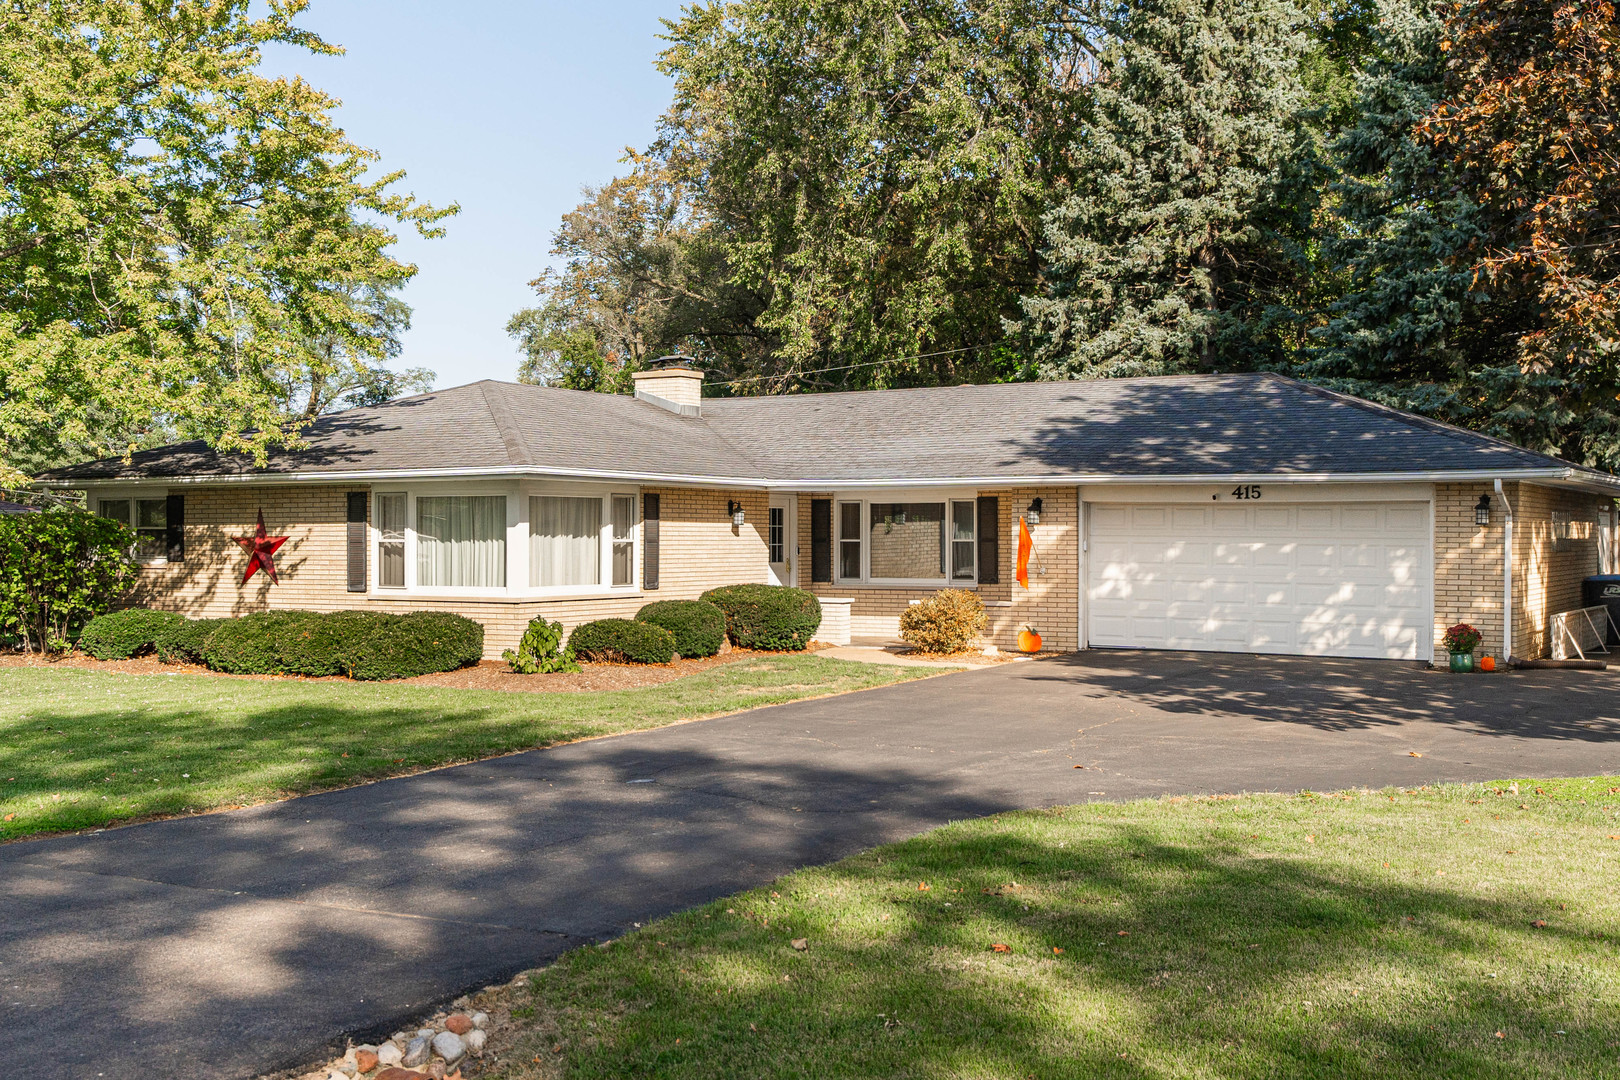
[34,364,1620,661]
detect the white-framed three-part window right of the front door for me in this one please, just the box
[838,499,978,585]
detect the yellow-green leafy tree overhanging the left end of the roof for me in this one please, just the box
[0,0,454,473]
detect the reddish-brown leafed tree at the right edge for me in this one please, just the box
[1421,0,1620,466]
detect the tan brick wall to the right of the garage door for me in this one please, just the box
[1434,483,1612,659]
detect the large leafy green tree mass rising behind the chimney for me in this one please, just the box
[525,0,1100,392]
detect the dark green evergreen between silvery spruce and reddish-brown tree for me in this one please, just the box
[1293,0,1620,465]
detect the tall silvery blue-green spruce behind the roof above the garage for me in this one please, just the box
[1024,0,1309,379]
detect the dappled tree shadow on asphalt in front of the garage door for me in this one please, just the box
[1021,649,1620,742]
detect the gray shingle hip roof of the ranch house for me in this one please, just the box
[47,376,1612,483]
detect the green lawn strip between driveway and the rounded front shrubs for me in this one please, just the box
[0,656,936,839]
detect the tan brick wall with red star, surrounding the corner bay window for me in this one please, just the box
[123,484,770,659]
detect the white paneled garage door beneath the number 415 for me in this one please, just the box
[1087,502,1432,659]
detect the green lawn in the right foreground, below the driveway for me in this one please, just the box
[496,777,1620,1080]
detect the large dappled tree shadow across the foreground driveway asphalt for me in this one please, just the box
[0,744,1023,1077]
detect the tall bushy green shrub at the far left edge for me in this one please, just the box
[0,510,139,653]
